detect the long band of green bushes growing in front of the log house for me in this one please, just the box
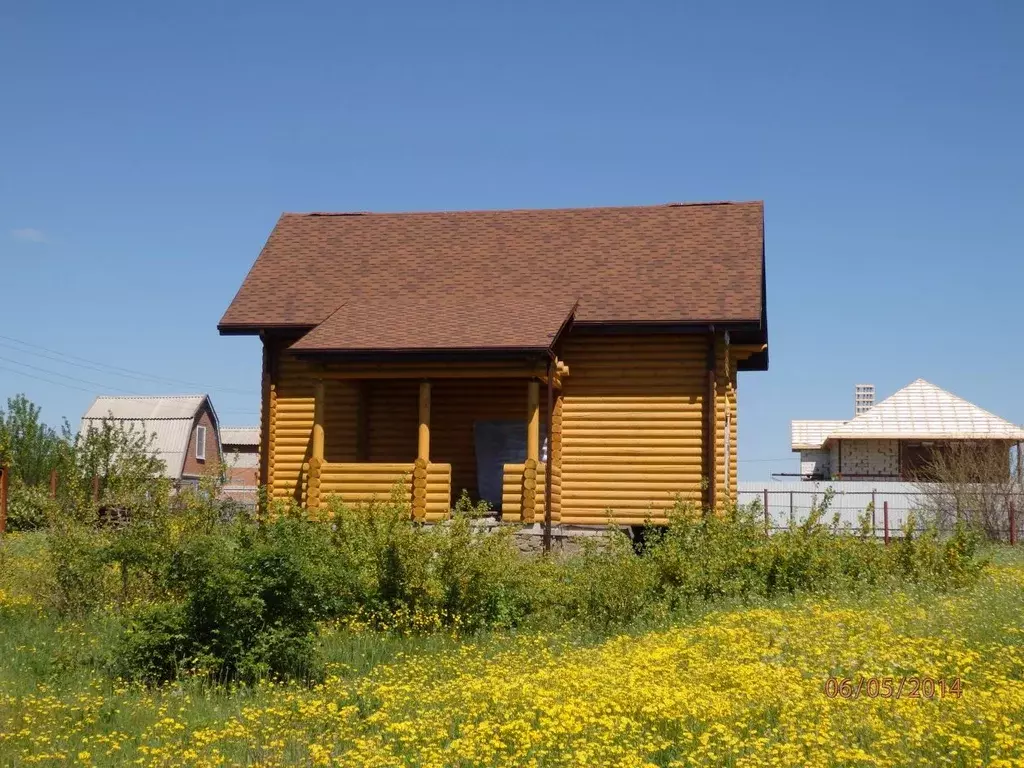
[0,402,982,684]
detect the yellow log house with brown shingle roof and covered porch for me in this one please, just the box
[218,203,768,525]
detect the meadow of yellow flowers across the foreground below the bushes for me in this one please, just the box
[6,565,1024,766]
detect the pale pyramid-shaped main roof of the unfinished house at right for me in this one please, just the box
[826,379,1024,441]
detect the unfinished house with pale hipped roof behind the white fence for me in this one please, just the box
[792,379,1024,480]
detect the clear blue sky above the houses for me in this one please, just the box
[0,0,1024,479]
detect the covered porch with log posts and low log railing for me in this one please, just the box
[296,353,568,522]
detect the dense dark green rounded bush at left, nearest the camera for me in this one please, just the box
[118,518,337,682]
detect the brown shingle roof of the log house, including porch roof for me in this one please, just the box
[219,202,764,349]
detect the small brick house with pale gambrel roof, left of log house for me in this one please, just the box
[81,394,220,482]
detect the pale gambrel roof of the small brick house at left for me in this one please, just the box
[82,394,217,478]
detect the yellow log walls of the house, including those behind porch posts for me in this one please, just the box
[263,334,737,525]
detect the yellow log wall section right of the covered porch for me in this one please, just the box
[560,334,736,524]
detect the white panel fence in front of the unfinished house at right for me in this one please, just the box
[737,480,1024,544]
